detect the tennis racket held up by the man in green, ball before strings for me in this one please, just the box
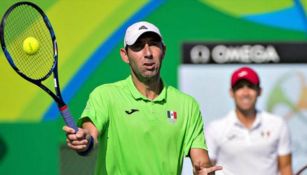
[0,2,78,132]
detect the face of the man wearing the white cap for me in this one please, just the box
[122,33,165,80]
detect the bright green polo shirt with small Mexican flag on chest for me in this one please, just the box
[79,76,207,175]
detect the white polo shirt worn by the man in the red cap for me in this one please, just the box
[206,111,291,175]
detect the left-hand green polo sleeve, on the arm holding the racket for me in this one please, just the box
[78,87,109,131]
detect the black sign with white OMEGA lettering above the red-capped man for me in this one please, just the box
[183,43,307,64]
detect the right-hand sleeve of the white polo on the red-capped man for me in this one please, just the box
[278,121,291,156]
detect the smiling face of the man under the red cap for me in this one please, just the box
[230,80,261,112]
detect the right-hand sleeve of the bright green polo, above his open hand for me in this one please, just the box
[184,101,207,156]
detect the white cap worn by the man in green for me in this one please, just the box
[124,21,162,47]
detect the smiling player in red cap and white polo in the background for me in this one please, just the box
[206,67,292,175]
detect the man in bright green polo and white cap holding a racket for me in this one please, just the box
[63,21,221,175]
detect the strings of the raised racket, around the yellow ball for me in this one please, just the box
[4,5,55,80]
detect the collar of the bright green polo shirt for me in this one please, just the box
[126,75,167,102]
